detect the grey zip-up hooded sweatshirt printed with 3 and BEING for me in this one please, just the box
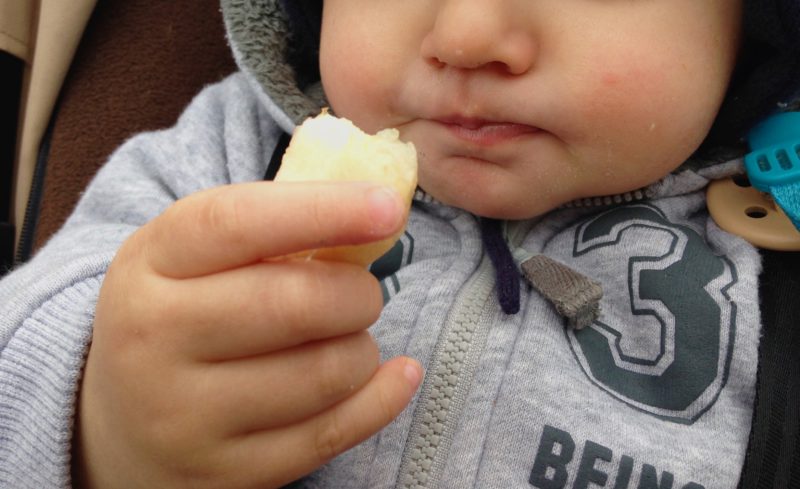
[0,0,796,489]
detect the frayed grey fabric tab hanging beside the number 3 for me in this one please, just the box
[521,255,603,329]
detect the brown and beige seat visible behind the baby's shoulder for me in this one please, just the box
[0,0,235,275]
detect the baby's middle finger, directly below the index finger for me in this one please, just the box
[174,260,383,362]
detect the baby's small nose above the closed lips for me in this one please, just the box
[421,0,536,75]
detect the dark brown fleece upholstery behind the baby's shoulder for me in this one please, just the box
[34,0,235,249]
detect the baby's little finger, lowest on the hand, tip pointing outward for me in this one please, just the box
[234,357,422,487]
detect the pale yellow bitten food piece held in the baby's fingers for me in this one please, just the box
[275,111,417,266]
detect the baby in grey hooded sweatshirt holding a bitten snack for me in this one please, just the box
[0,0,800,489]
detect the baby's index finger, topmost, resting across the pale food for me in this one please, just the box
[140,182,403,278]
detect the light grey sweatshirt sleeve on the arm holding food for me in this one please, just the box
[0,75,422,489]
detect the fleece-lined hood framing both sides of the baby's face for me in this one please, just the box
[221,0,800,170]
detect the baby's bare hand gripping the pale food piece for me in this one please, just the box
[74,182,421,488]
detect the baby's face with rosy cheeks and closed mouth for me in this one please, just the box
[320,0,741,218]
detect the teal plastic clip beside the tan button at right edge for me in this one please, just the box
[744,112,800,230]
